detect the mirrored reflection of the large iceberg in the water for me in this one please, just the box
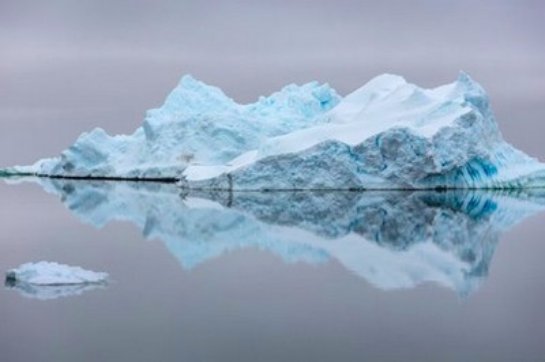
[11,179,545,295]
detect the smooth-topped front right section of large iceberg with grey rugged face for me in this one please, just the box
[186,73,545,190]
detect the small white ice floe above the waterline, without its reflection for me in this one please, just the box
[6,261,108,286]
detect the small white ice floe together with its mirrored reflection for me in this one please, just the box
[5,261,108,300]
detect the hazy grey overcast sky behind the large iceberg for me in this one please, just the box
[0,0,545,167]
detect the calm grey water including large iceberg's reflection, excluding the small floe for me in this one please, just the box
[0,180,545,361]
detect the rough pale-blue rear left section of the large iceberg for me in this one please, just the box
[10,76,340,180]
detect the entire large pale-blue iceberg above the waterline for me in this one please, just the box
[3,73,545,190]
